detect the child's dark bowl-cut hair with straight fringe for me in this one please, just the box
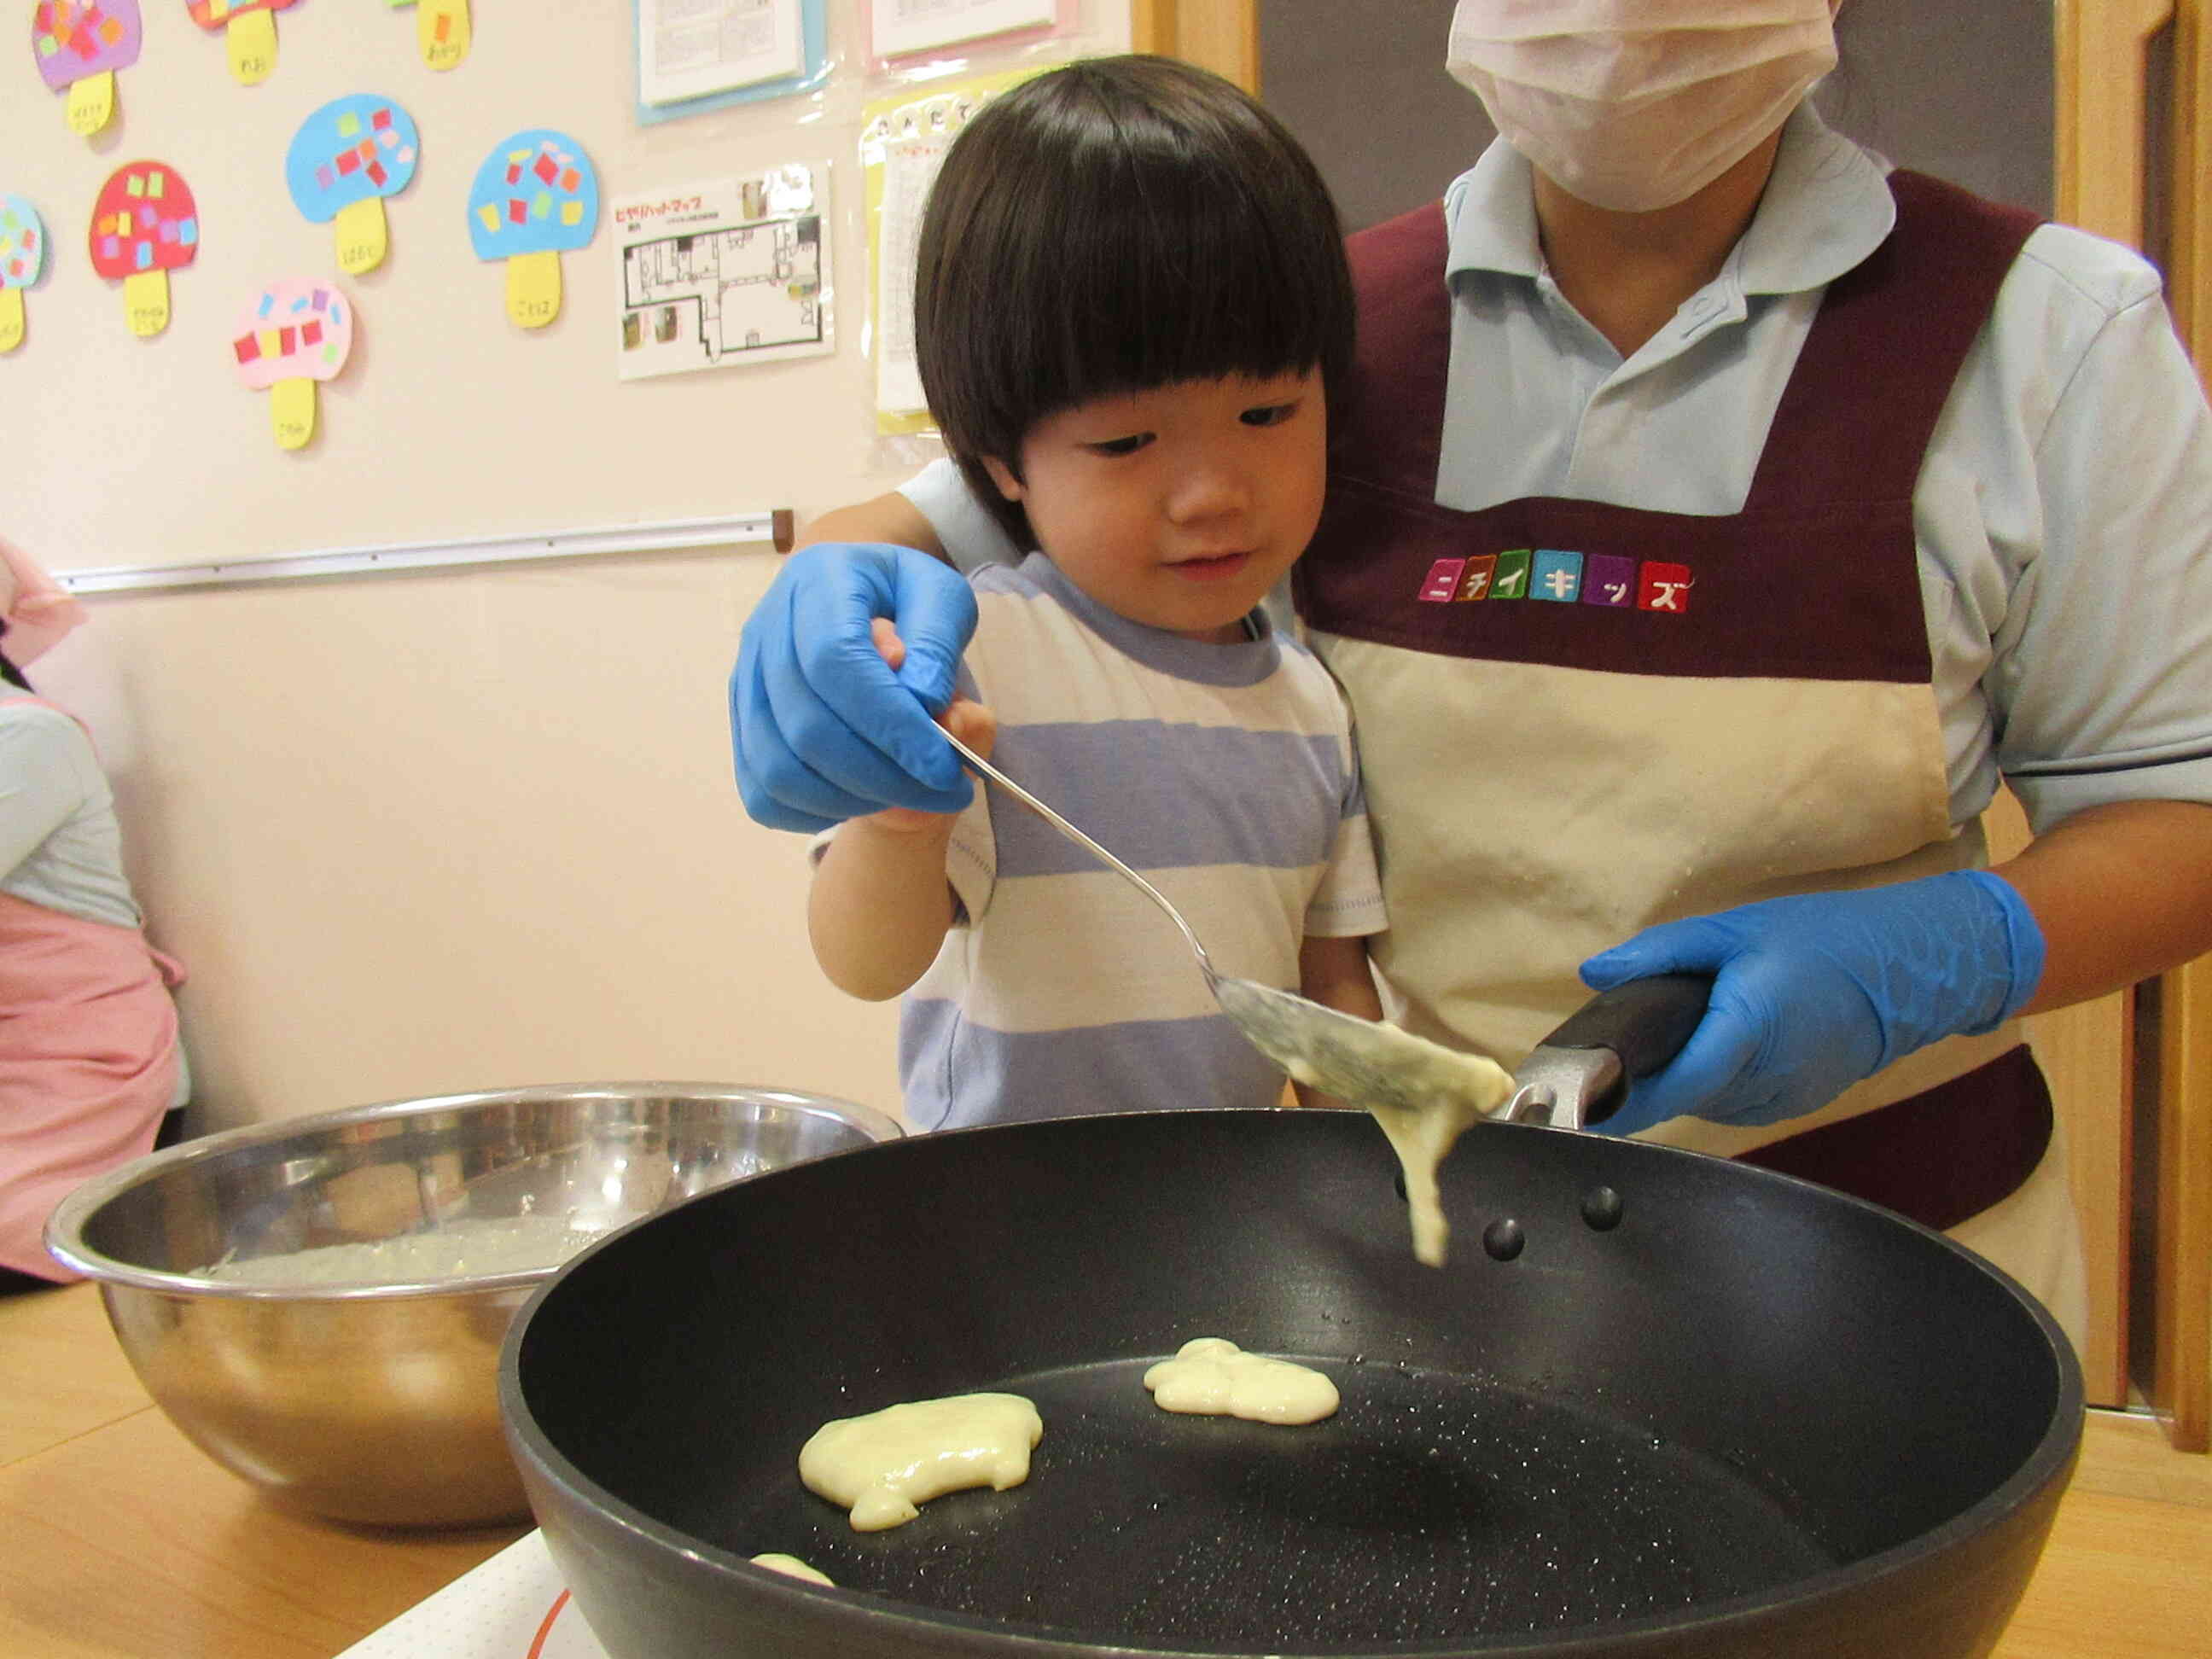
[913,55,1353,549]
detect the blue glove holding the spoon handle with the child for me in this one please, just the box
[730,542,975,832]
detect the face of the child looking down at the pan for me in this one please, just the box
[984,370,1327,642]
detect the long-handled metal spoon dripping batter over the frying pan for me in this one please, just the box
[945,732,1511,1113]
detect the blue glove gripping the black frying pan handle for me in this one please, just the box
[1581,870,2044,1135]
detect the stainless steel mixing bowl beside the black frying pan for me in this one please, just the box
[46,1081,900,1526]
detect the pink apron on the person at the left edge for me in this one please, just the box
[0,696,183,1278]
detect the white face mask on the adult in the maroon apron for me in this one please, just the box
[1445,0,1836,212]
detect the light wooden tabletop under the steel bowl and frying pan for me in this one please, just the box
[0,1285,2212,1659]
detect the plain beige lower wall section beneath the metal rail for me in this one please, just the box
[40,549,916,1128]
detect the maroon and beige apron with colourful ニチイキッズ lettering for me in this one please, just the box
[1296,172,2081,1338]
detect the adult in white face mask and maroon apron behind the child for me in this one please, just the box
[732,0,2212,1341]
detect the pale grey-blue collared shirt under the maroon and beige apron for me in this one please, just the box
[905,104,2212,830]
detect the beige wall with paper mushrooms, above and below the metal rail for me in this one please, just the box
[0,0,1128,1131]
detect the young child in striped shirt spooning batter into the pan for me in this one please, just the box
[807,57,1382,1128]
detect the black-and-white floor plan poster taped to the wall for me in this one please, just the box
[615,161,834,381]
